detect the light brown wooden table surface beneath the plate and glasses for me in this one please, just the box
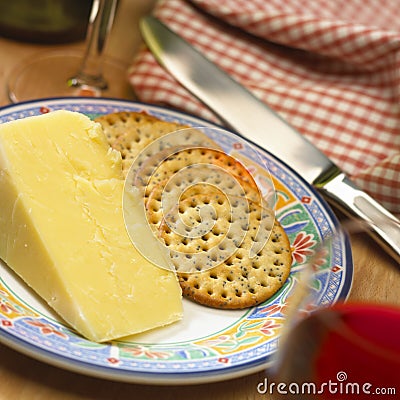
[0,0,400,400]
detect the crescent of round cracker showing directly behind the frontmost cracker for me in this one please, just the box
[141,148,261,245]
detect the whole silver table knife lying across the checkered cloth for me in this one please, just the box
[140,16,400,264]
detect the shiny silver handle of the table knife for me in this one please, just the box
[320,174,400,266]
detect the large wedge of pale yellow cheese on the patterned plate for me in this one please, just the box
[0,111,182,342]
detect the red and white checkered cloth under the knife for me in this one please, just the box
[129,0,400,214]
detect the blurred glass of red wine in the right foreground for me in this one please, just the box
[268,221,400,400]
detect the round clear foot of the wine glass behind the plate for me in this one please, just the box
[7,51,133,103]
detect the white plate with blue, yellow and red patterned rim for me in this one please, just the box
[0,98,353,384]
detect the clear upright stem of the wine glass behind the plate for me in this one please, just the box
[68,0,118,90]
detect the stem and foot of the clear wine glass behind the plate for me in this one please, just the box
[7,0,127,103]
